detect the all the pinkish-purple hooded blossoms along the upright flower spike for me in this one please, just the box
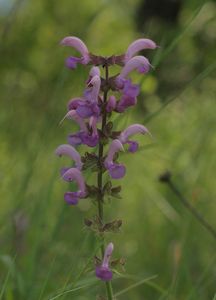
[56,36,157,281]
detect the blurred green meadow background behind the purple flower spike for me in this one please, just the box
[0,0,216,300]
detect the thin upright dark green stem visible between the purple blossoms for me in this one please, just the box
[97,65,113,300]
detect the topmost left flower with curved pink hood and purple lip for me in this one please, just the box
[60,36,90,69]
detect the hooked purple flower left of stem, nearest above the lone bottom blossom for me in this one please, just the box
[62,168,86,205]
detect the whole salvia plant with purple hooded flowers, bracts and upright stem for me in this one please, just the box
[56,36,157,300]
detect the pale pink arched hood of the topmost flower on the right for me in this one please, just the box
[125,39,157,62]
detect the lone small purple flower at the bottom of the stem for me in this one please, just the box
[95,243,114,281]
